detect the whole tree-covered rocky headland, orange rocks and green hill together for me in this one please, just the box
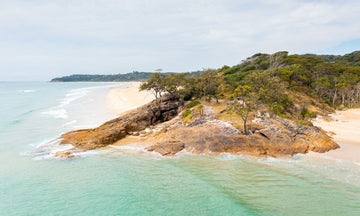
[56,51,360,158]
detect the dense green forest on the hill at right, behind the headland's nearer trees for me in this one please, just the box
[220,52,360,107]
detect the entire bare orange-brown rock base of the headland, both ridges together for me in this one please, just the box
[58,95,339,157]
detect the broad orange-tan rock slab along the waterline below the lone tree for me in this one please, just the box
[147,109,339,157]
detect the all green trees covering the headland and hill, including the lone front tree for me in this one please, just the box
[140,51,360,131]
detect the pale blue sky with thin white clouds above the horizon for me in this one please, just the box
[0,0,360,81]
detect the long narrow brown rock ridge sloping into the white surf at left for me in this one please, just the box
[61,95,184,150]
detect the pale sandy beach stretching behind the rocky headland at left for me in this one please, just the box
[105,82,155,115]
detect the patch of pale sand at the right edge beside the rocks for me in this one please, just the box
[312,109,360,162]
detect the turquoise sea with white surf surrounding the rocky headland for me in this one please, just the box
[0,82,360,215]
